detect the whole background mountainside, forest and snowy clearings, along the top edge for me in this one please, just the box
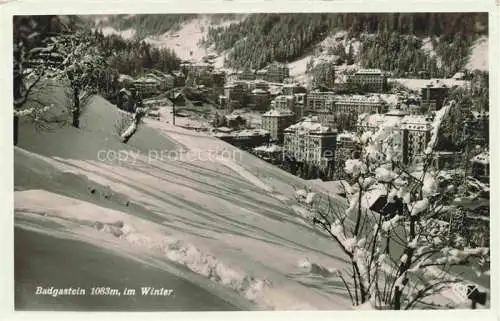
[89,13,488,77]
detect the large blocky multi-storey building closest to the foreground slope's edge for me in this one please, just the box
[283,116,337,168]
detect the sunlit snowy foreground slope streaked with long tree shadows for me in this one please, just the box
[15,91,350,310]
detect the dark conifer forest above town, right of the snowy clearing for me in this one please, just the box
[203,13,488,77]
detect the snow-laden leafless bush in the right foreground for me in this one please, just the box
[300,101,489,310]
